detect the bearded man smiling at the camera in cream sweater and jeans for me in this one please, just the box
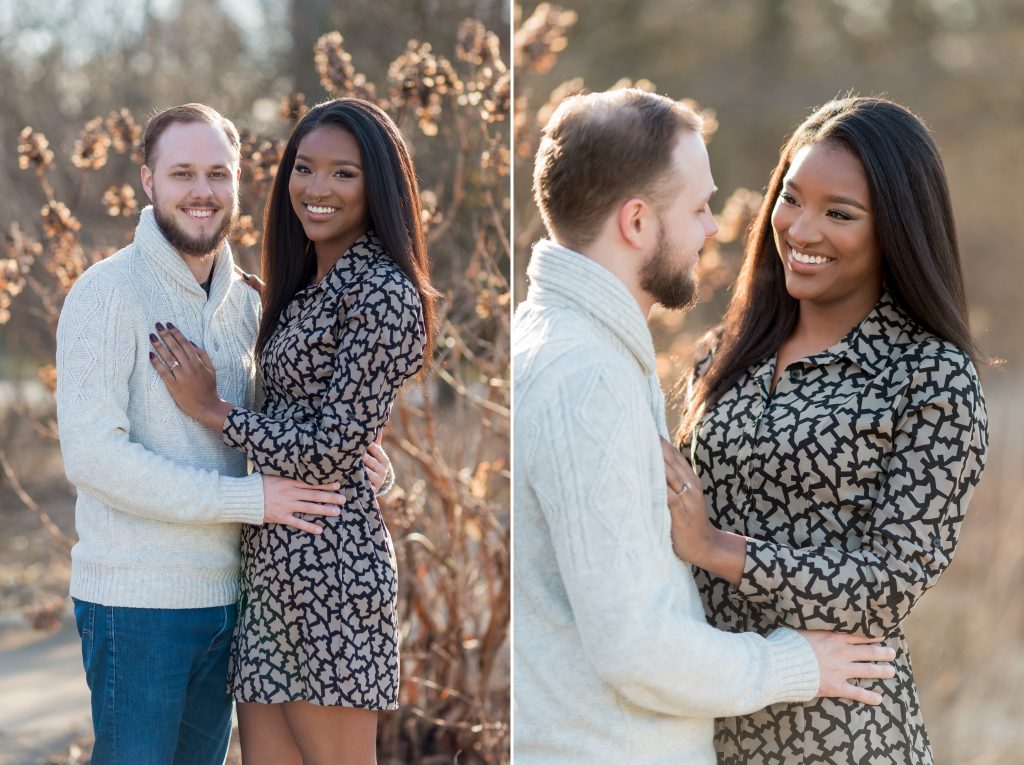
[57,103,387,765]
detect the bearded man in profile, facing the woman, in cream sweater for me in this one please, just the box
[512,90,894,765]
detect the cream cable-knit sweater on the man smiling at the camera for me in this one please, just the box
[57,207,263,608]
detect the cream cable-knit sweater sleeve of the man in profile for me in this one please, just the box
[516,364,819,717]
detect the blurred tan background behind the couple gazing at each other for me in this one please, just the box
[513,0,1024,765]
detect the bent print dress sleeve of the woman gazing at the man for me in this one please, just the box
[736,358,988,636]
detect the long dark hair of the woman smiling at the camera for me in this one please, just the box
[256,98,438,367]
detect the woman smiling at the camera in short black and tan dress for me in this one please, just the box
[154,98,436,765]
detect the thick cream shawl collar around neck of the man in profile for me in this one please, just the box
[526,240,656,375]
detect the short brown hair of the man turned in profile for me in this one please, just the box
[534,88,702,250]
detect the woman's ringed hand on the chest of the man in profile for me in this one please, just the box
[662,438,746,585]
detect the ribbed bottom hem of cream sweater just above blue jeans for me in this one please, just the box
[71,560,239,608]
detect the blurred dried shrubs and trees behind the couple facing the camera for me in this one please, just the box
[0,0,511,765]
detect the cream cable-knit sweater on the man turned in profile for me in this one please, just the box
[512,241,818,765]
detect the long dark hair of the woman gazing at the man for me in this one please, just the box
[680,97,980,439]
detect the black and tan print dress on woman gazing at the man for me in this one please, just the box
[690,293,987,765]
